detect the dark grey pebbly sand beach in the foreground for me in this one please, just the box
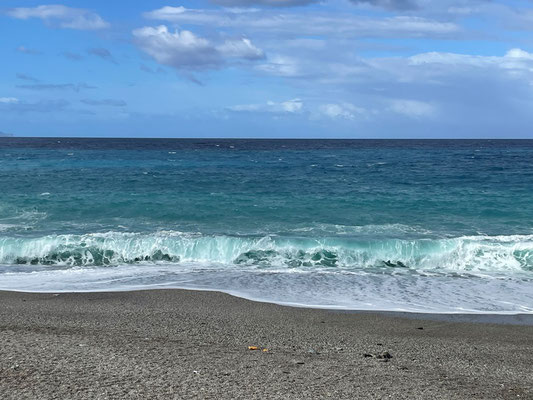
[0,290,533,399]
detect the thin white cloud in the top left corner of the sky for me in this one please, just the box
[6,5,109,30]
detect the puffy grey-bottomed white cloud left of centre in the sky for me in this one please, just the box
[133,25,263,69]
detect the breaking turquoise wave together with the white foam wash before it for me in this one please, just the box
[0,231,533,313]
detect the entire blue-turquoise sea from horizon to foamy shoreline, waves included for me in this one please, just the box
[0,138,533,313]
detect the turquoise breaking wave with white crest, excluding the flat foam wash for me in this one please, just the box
[0,231,533,272]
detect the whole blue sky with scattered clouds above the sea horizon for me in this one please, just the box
[0,0,533,138]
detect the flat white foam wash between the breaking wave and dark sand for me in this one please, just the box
[0,263,533,314]
